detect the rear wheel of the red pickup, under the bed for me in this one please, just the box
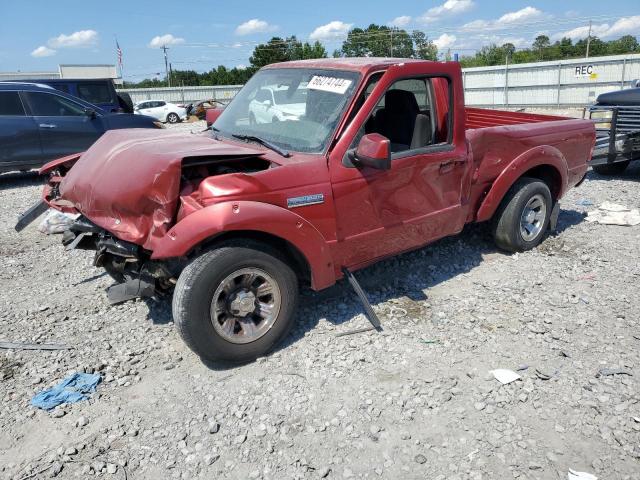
[492,177,553,252]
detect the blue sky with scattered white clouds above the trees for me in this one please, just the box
[0,0,640,81]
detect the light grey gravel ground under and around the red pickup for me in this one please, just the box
[0,124,640,480]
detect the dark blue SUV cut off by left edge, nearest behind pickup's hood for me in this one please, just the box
[0,82,163,173]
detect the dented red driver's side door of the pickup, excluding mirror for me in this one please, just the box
[330,68,469,267]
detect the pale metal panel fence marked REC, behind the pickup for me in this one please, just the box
[119,55,640,108]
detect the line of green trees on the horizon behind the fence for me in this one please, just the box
[125,24,640,88]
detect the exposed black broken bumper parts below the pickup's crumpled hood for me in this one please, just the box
[62,216,183,304]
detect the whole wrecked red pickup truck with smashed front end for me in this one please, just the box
[18,58,595,360]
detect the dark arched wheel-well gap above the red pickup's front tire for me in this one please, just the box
[189,230,311,283]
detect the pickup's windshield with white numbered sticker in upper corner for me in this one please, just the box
[214,68,359,153]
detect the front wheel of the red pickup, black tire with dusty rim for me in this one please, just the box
[173,241,298,362]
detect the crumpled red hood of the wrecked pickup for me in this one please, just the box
[60,129,264,248]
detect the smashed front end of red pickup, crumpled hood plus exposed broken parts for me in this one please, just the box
[16,130,271,303]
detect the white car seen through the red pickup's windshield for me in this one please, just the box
[249,86,307,125]
